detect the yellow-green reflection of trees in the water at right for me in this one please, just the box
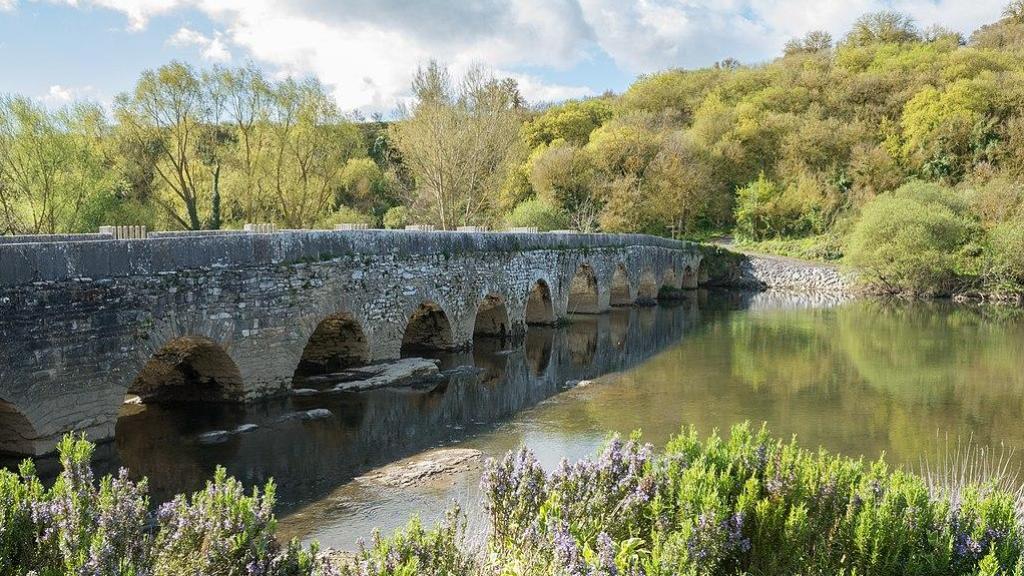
[667,301,1024,463]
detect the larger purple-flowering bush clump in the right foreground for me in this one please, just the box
[347,425,1024,576]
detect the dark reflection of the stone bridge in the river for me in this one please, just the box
[32,298,699,506]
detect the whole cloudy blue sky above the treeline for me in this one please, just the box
[0,0,1009,115]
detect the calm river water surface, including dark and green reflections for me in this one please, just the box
[8,293,1024,548]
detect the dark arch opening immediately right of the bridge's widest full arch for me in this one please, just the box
[295,313,370,377]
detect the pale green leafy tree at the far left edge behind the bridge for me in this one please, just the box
[0,96,113,234]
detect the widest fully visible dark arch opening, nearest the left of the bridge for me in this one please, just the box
[128,336,245,403]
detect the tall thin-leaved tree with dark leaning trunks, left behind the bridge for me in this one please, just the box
[115,63,219,230]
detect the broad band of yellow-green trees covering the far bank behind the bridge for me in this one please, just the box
[6,1,1024,293]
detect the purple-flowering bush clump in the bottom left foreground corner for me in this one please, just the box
[0,436,336,576]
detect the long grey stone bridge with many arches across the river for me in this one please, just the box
[0,231,701,454]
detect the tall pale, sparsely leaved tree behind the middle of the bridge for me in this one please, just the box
[391,61,522,230]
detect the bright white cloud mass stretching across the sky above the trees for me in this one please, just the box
[48,0,1007,112]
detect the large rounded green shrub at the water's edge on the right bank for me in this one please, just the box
[847,182,984,294]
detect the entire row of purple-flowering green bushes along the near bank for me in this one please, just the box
[8,425,1024,576]
